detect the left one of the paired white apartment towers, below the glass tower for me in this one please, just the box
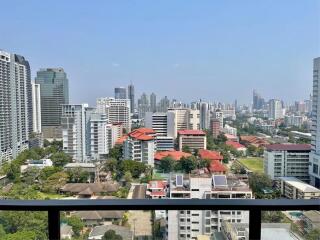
[61,103,89,162]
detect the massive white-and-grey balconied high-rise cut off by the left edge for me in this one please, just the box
[0,50,33,164]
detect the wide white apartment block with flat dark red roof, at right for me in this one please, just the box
[264,144,311,182]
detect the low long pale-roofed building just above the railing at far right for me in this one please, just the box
[279,177,320,199]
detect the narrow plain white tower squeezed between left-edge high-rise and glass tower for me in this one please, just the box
[32,83,41,133]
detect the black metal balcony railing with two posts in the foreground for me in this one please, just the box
[0,199,320,240]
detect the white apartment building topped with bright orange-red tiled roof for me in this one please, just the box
[123,128,156,166]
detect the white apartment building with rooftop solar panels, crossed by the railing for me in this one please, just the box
[166,174,253,240]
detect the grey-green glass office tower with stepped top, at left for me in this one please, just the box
[35,68,69,138]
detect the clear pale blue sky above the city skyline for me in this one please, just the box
[0,0,320,104]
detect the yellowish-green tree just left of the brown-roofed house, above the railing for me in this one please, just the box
[42,172,69,193]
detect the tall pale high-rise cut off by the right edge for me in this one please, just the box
[309,57,320,188]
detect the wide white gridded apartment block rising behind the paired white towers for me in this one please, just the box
[97,97,131,132]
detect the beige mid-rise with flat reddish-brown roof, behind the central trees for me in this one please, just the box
[178,130,207,151]
